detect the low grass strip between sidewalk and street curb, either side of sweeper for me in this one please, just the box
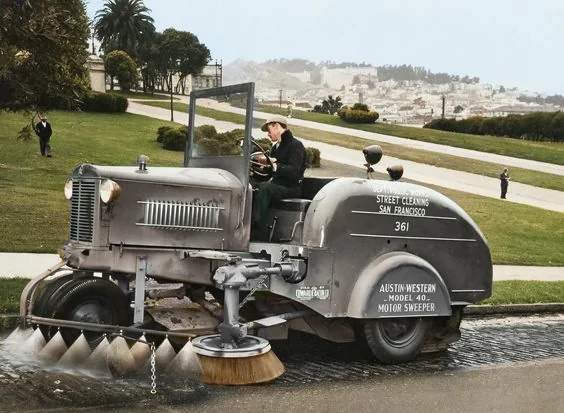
[0,278,564,314]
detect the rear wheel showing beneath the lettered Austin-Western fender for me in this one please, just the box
[364,317,429,364]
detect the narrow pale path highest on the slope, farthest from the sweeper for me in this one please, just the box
[177,95,564,176]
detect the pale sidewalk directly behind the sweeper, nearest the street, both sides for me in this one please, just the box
[0,252,564,281]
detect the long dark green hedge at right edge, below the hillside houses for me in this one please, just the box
[423,112,564,142]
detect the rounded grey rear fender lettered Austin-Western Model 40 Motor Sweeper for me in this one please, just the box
[347,252,452,318]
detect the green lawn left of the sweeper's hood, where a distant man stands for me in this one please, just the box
[0,111,183,252]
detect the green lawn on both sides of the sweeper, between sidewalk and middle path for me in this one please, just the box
[0,111,564,265]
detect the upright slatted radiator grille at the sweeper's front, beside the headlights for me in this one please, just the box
[70,180,96,242]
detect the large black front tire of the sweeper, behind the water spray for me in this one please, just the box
[35,278,131,347]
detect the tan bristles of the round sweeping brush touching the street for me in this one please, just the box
[198,350,284,385]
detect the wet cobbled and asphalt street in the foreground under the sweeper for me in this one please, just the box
[0,315,564,413]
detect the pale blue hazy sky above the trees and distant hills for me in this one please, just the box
[87,0,564,94]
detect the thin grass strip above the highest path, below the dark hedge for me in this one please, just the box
[255,105,564,165]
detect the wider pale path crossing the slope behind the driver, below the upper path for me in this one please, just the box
[127,101,564,212]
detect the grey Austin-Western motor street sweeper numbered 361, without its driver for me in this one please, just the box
[8,83,492,384]
